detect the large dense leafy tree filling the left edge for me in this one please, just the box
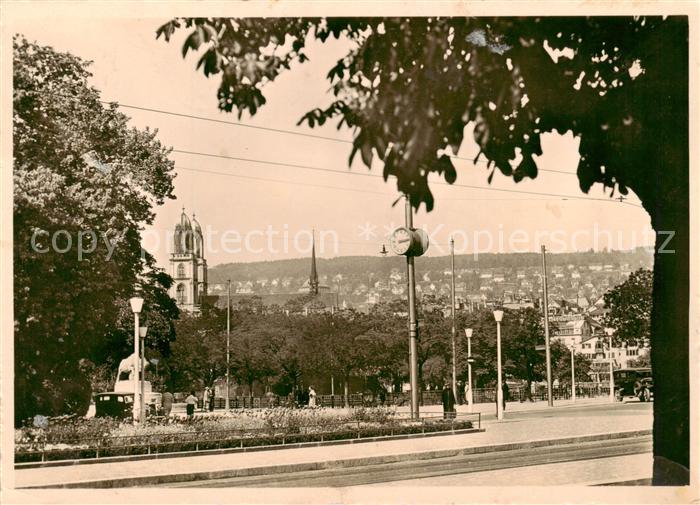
[13,36,177,421]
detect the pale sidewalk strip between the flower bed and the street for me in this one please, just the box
[14,403,653,488]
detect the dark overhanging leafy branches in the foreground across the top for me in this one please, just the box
[157,17,687,215]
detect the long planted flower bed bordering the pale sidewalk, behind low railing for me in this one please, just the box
[15,407,472,463]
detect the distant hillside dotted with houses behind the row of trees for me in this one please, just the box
[209,248,653,310]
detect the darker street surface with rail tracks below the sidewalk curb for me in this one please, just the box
[168,436,651,487]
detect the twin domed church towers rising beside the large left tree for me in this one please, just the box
[169,207,207,312]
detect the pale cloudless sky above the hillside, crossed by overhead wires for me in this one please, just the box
[12,15,653,267]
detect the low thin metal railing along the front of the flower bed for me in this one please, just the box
[15,412,481,464]
